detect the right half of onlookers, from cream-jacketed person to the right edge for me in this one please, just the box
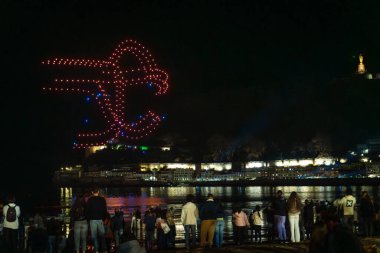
[181,187,379,249]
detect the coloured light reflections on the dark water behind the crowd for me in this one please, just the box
[60,186,379,240]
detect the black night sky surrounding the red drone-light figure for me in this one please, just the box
[0,0,380,186]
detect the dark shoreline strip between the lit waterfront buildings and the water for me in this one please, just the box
[55,178,380,187]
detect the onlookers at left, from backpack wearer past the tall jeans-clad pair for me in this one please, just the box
[0,189,145,253]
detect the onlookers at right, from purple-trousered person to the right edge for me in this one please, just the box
[268,187,379,245]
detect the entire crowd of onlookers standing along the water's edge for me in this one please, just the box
[0,188,380,253]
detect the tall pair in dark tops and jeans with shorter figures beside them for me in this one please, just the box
[70,189,145,253]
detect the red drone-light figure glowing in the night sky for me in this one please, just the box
[42,40,169,148]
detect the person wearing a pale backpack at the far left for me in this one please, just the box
[3,195,21,253]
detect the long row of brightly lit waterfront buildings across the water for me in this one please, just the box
[54,158,380,184]
